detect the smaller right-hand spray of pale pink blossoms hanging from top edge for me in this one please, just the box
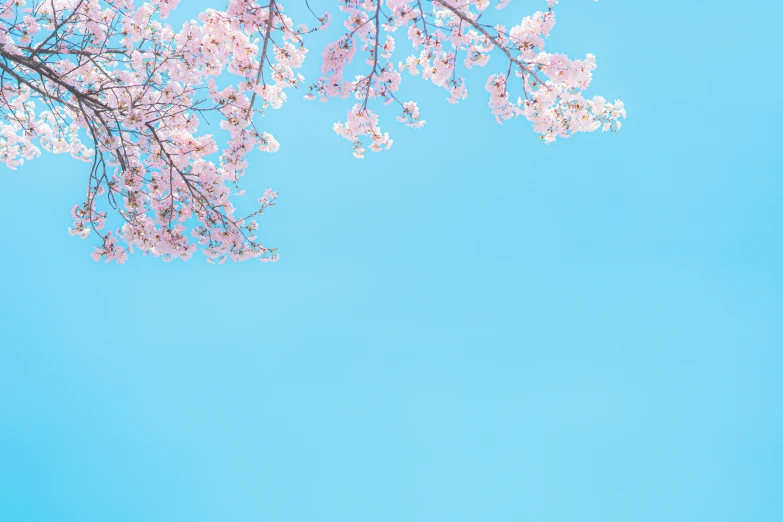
[307,0,626,154]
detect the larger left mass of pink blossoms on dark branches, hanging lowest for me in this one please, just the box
[0,0,318,263]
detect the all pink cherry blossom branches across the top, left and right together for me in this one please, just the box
[0,0,625,263]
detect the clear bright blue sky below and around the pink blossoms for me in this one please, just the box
[0,0,783,522]
